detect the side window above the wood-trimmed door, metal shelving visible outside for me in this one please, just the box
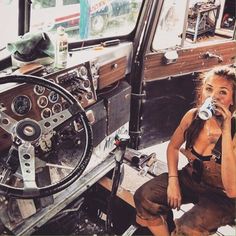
[152,0,236,51]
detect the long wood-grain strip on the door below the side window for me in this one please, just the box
[144,42,236,81]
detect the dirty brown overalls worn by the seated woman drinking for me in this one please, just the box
[134,120,236,236]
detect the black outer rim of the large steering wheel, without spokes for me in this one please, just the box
[0,75,93,198]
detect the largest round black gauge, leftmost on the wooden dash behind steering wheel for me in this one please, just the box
[11,95,32,116]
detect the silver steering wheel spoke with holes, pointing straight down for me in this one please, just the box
[18,142,37,191]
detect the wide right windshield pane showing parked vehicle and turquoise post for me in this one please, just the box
[30,0,142,42]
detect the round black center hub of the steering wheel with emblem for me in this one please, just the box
[16,119,42,142]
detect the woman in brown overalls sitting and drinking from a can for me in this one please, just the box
[134,67,236,236]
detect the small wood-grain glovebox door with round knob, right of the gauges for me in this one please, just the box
[98,57,127,89]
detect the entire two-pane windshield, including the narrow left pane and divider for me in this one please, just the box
[0,0,142,59]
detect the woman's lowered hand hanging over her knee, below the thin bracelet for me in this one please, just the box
[167,177,181,210]
